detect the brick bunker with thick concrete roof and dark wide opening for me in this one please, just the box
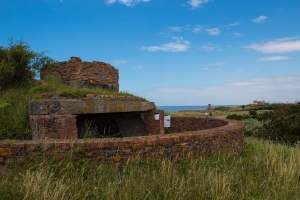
[29,95,164,140]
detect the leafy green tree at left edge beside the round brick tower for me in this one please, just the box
[0,39,54,89]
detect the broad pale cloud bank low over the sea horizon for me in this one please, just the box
[139,74,300,106]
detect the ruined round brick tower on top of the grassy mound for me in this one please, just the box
[41,57,119,91]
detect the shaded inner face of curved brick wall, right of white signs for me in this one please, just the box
[169,117,228,133]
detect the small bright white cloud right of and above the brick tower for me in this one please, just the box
[141,37,190,52]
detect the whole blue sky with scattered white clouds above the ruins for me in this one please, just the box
[0,0,300,106]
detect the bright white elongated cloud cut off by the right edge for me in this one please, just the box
[244,37,300,53]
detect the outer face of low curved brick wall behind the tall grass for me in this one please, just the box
[0,120,244,170]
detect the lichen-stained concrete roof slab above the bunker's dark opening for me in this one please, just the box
[29,97,156,115]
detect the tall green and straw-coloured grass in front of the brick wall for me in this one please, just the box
[0,137,300,200]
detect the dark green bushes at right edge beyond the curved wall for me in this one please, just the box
[226,103,300,144]
